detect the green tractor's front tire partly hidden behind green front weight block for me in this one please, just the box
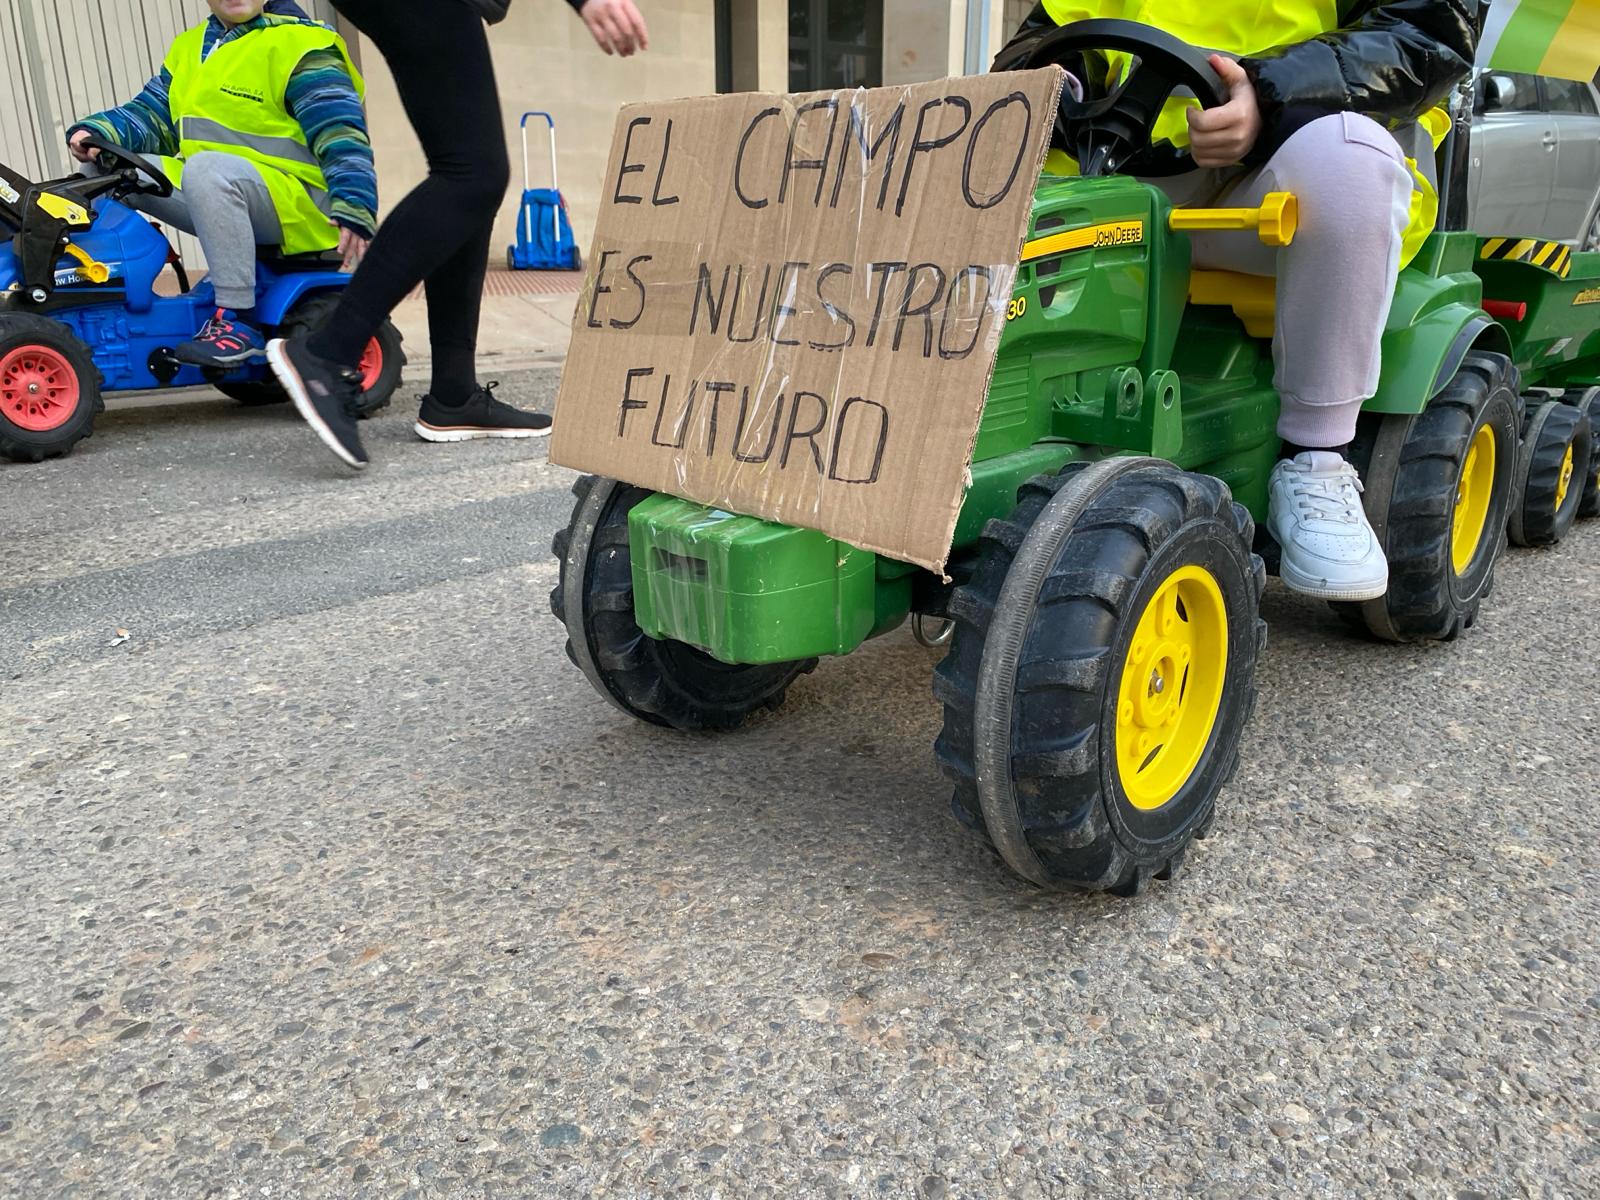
[550,475,816,730]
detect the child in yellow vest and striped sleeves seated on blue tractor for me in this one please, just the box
[67,0,378,368]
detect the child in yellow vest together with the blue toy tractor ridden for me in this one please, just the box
[0,0,405,462]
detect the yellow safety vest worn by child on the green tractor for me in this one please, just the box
[1043,0,1450,264]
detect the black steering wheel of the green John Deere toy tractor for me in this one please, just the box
[994,18,1229,178]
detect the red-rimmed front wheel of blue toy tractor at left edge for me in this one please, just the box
[0,312,106,462]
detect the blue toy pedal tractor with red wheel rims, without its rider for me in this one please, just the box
[0,138,405,462]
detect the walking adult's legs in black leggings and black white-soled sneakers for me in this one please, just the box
[269,0,549,467]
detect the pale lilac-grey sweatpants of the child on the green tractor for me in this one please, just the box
[1152,112,1413,446]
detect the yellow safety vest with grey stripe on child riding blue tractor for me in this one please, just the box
[163,21,363,254]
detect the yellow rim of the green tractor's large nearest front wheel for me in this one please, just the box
[1117,565,1227,810]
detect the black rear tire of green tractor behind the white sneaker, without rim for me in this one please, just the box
[1333,350,1522,642]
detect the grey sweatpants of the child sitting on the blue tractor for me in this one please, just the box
[83,150,324,309]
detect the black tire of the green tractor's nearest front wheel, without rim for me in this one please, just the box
[934,458,1267,896]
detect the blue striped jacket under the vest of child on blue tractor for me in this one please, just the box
[67,14,378,237]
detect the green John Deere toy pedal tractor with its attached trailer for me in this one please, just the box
[552,21,1600,894]
